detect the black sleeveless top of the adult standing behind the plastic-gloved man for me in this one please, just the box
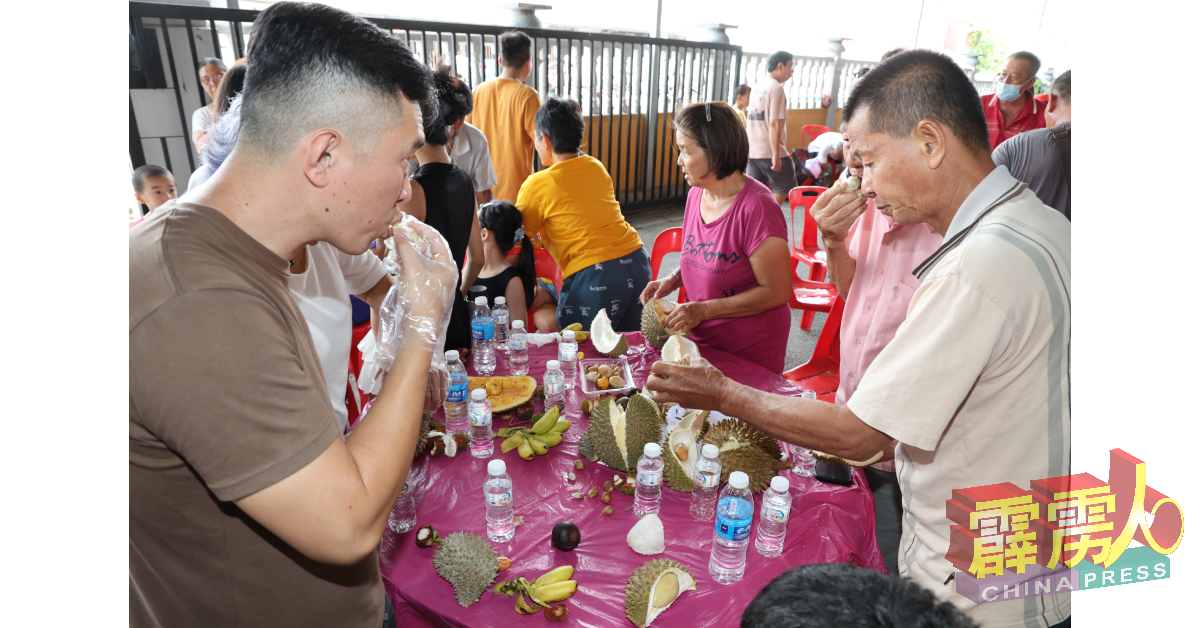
[413,163,475,349]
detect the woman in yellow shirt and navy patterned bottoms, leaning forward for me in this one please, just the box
[517,98,650,331]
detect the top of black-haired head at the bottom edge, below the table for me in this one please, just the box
[742,563,979,628]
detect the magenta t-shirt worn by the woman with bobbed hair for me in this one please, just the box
[679,179,792,372]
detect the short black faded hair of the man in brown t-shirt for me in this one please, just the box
[238,2,431,160]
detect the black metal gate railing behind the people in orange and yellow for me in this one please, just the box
[130,2,742,209]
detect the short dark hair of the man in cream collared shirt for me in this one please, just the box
[842,50,991,151]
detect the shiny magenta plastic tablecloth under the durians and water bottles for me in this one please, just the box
[379,334,884,628]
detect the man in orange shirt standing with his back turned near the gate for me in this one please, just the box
[467,31,541,201]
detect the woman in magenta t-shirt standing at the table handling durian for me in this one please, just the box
[641,102,792,372]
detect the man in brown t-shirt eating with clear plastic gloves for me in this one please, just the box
[130,2,456,628]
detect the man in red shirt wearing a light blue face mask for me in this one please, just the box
[979,50,1046,150]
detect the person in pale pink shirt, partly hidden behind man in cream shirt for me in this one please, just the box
[812,124,942,574]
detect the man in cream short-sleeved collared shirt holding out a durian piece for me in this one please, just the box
[646,50,1070,628]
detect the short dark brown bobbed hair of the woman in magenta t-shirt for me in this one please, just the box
[674,101,750,179]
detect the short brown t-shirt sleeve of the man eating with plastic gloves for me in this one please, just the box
[130,289,338,501]
